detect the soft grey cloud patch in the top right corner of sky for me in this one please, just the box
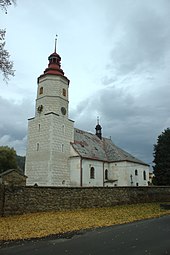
[107,1,170,74]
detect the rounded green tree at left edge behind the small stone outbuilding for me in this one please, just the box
[0,146,17,173]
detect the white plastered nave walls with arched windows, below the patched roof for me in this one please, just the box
[70,157,149,187]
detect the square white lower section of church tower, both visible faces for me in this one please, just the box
[26,111,73,186]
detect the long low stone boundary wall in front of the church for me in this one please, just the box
[0,185,170,216]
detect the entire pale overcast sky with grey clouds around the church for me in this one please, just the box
[0,0,170,167]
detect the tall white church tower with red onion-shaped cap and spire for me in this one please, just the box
[25,40,74,186]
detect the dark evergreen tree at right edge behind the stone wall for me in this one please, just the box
[153,128,170,185]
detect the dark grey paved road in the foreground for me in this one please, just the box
[0,216,170,255]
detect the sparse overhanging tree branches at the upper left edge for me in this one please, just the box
[0,0,16,80]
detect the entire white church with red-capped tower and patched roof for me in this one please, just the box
[25,41,149,187]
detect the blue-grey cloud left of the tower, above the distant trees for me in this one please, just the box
[0,98,33,155]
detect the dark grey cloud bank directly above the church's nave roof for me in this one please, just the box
[71,68,170,163]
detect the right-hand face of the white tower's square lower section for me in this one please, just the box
[48,115,74,186]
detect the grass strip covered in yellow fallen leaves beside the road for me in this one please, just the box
[0,203,170,241]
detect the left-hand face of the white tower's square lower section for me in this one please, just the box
[25,116,50,185]
